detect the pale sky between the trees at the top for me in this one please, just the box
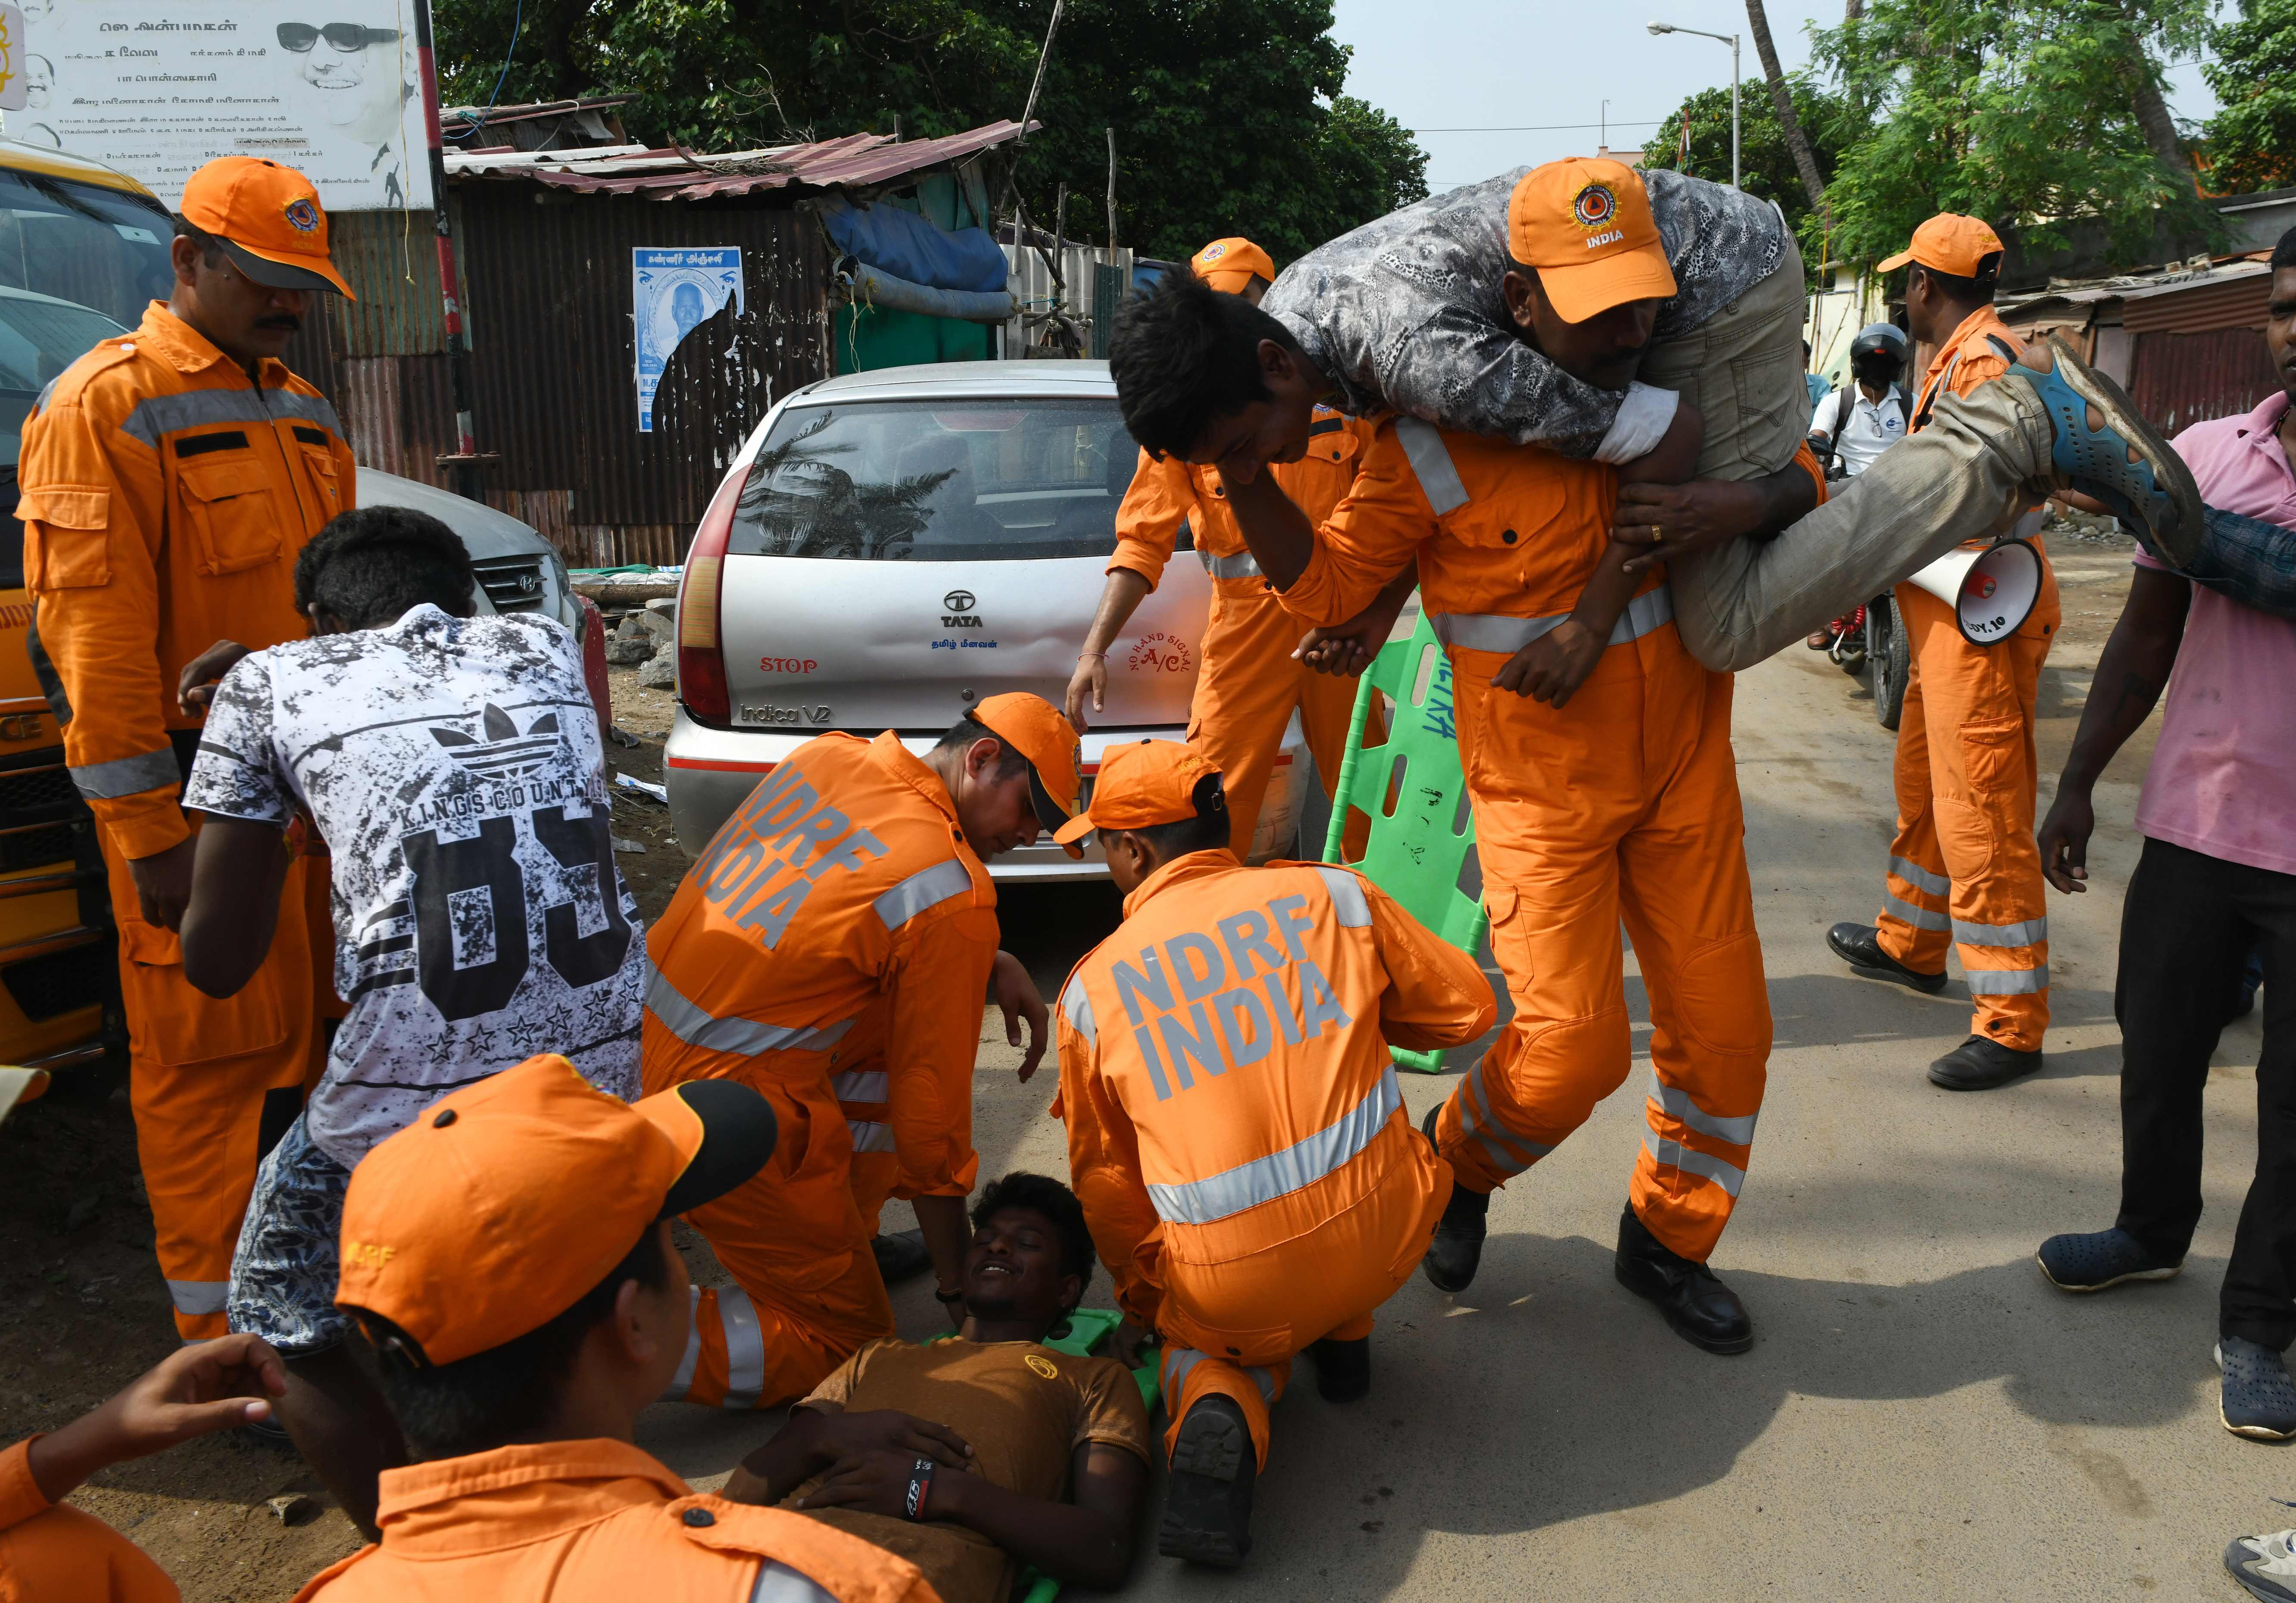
[1332,0,2216,193]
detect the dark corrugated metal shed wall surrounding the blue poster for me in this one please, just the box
[457,184,831,546]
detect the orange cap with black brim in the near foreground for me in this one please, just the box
[335,1052,776,1364]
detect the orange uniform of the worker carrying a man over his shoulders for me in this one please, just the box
[1283,418,1770,1261]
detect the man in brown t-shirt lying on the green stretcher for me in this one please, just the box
[723,1173,1150,1603]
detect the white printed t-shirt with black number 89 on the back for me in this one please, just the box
[184,604,645,1166]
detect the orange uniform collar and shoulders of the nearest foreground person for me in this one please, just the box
[296,1440,941,1603]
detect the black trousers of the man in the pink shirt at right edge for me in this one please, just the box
[2112,838,2296,1350]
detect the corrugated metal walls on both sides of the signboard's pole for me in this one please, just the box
[285,184,833,565]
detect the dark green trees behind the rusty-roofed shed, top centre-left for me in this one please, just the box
[436,0,1426,262]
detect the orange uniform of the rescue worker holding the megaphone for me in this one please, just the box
[1878,306,2062,1052]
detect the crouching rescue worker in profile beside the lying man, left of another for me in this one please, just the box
[641,694,1084,1408]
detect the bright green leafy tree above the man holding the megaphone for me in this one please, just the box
[1814,0,2216,262]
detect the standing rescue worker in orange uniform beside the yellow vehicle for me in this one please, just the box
[16,156,356,1341]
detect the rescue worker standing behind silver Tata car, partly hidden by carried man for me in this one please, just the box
[1068,239,1410,857]
